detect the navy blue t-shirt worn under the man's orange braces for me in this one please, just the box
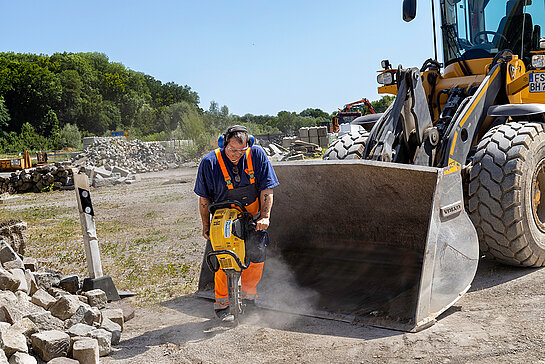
[194,145,278,203]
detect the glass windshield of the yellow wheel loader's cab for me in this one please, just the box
[440,0,545,64]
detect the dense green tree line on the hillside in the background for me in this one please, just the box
[0,52,391,153]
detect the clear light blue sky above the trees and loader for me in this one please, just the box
[0,0,433,115]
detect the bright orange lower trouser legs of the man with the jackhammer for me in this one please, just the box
[214,262,265,310]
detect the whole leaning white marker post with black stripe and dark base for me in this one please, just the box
[73,173,120,301]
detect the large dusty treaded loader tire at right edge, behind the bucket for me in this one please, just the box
[469,122,545,267]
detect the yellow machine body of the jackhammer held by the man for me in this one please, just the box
[210,208,246,271]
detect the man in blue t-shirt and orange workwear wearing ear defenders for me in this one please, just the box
[194,125,278,322]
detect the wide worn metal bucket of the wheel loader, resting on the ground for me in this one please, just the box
[258,160,479,331]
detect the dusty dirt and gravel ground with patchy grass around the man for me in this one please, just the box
[0,168,545,364]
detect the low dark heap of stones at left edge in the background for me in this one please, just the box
[0,162,74,194]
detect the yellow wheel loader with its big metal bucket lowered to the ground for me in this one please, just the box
[198,0,545,332]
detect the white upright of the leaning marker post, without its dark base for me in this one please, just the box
[73,173,103,279]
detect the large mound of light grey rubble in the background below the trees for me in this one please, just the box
[72,138,182,174]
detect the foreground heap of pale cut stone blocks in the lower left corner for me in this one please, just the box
[0,220,134,364]
